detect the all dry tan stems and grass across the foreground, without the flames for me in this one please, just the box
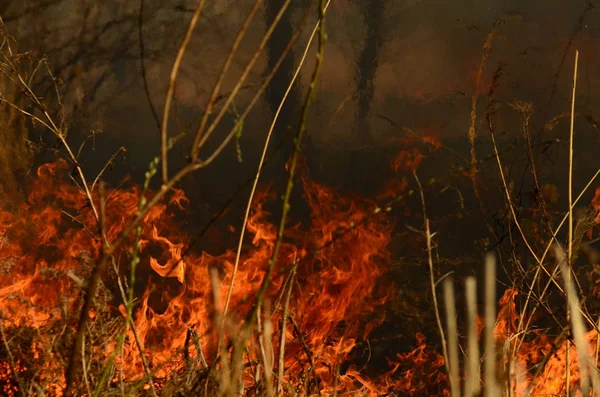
[0,5,600,397]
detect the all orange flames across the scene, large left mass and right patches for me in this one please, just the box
[0,157,598,396]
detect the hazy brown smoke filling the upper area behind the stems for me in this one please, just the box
[2,0,600,203]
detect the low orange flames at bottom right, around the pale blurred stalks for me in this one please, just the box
[385,288,599,397]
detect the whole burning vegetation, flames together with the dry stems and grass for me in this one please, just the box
[0,1,600,397]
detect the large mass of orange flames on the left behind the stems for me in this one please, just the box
[0,161,392,394]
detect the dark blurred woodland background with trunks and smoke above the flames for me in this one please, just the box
[0,0,600,276]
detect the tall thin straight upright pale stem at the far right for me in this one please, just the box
[561,51,586,393]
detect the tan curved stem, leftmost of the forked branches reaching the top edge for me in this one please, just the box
[161,0,205,183]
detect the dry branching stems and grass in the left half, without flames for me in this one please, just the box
[0,0,327,396]
